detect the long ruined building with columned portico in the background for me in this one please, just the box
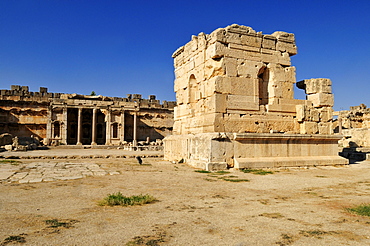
[0,85,175,145]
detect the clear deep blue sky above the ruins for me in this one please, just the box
[0,0,370,110]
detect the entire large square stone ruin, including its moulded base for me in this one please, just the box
[164,24,348,170]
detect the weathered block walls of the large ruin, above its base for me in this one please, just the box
[173,25,333,134]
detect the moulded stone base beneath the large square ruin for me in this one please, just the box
[164,133,349,170]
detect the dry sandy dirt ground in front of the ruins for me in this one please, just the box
[0,158,370,246]
